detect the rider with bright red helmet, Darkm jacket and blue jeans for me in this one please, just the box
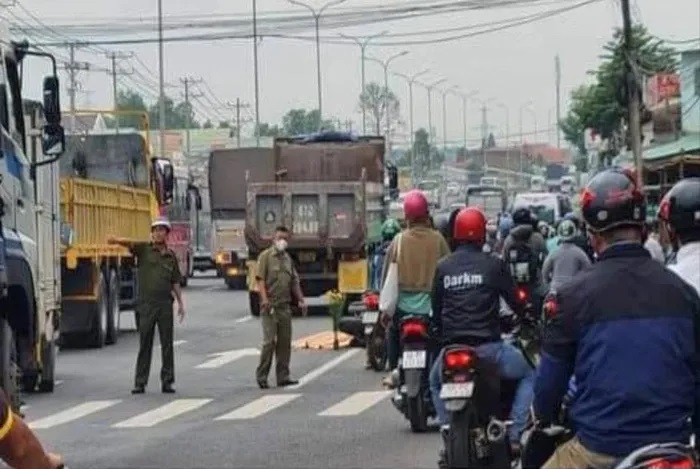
[430,207,534,450]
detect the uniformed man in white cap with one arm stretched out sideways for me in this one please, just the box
[108,217,185,394]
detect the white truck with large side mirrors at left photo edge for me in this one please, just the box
[0,34,65,411]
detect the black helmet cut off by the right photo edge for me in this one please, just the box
[658,177,700,234]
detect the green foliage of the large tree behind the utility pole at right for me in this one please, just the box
[560,25,678,159]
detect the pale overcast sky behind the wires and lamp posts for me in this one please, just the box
[5,0,700,145]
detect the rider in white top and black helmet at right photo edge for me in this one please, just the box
[658,178,700,292]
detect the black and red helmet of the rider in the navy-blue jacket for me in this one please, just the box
[581,168,646,232]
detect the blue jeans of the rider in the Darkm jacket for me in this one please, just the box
[430,342,535,442]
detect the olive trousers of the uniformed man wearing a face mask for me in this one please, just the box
[255,305,292,384]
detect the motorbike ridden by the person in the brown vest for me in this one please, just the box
[391,316,436,433]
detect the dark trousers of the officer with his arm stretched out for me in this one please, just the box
[135,303,175,387]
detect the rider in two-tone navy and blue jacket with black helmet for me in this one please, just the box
[534,169,700,469]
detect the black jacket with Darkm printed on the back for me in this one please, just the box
[432,245,518,346]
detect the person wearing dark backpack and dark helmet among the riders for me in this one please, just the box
[503,208,547,311]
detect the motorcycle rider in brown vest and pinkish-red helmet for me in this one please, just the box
[382,190,450,387]
